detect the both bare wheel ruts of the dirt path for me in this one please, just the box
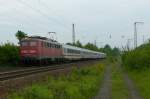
[94,63,143,99]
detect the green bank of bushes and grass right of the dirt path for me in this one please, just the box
[122,43,150,99]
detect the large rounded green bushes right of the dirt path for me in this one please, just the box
[122,43,150,69]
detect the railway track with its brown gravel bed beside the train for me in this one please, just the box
[0,60,100,99]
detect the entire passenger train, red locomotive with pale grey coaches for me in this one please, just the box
[20,36,106,64]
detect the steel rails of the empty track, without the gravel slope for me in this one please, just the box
[0,63,73,81]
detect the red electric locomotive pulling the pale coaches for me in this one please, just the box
[20,37,63,64]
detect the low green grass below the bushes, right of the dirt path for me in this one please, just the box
[128,68,150,99]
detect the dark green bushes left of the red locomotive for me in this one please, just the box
[0,43,19,64]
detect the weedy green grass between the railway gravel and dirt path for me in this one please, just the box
[8,64,104,99]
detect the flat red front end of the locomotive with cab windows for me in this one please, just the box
[20,39,41,64]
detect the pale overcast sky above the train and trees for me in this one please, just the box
[0,0,150,47]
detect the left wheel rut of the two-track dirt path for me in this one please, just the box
[94,65,111,99]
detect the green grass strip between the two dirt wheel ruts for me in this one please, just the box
[111,65,129,99]
